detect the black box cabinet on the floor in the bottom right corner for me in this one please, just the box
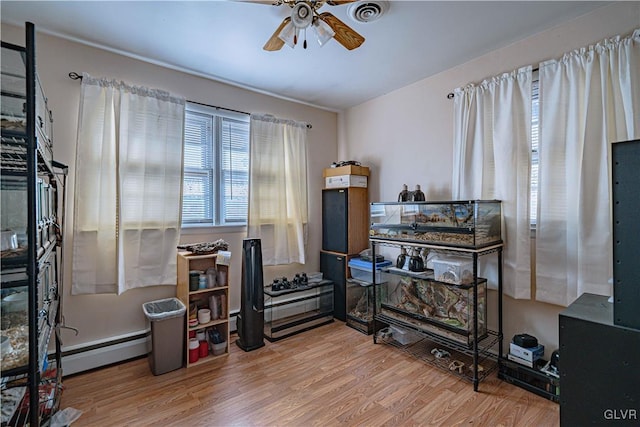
[559,294,640,427]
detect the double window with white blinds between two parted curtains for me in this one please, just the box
[182,103,249,226]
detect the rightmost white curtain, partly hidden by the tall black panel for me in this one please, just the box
[536,30,640,306]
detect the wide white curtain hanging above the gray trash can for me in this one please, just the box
[72,74,185,294]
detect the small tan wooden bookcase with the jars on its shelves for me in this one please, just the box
[177,252,230,367]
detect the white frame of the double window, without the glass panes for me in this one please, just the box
[181,101,250,235]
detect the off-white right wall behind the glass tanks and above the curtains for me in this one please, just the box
[338,2,640,356]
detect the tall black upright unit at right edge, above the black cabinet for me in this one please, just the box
[611,139,640,329]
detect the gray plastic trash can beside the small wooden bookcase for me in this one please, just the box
[142,298,187,375]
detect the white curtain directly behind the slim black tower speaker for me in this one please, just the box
[247,114,308,265]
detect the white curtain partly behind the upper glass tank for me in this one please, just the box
[453,67,532,298]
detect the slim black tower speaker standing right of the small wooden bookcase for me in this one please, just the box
[236,239,264,351]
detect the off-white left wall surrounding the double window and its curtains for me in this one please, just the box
[2,24,337,358]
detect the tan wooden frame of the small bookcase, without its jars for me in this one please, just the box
[177,252,230,368]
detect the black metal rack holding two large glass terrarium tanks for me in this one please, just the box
[369,200,503,391]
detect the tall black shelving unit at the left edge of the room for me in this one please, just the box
[0,23,67,426]
